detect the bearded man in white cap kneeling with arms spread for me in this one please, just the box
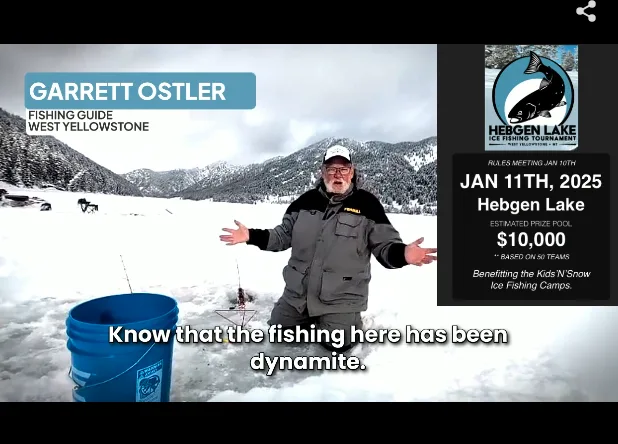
[220,145,437,352]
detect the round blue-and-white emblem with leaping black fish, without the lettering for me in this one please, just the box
[492,51,575,125]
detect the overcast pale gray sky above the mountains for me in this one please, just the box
[0,45,437,173]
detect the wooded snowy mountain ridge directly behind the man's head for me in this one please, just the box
[171,137,437,214]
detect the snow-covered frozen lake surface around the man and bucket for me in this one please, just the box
[0,185,618,401]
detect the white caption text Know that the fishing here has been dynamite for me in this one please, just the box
[109,325,509,376]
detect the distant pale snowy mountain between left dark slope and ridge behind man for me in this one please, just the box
[121,161,238,197]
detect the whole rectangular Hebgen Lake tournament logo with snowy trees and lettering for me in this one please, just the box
[485,45,579,151]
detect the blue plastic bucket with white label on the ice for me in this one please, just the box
[66,293,178,402]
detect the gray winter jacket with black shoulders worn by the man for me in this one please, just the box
[247,182,407,316]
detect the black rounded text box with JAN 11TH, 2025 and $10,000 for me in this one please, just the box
[453,152,610,303]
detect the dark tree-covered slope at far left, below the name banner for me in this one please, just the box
[0,108,142,196]
